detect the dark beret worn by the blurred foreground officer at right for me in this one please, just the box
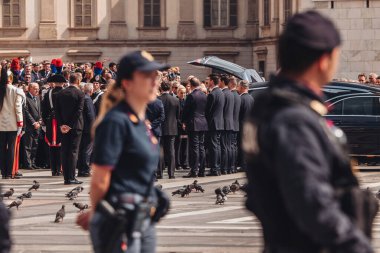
[282,11,341,51]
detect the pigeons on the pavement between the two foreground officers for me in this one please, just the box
[171,180,247,205]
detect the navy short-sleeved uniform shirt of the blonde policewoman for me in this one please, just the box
[94,102,159,198]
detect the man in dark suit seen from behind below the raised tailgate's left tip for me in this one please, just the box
[182,77,208,178]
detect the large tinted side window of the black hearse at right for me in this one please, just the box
[343,97,375,115]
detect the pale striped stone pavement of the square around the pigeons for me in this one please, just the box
[0,168,380,253]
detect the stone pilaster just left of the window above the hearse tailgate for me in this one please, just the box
[177,0,197,40]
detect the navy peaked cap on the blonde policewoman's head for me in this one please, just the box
[117,50,170,79]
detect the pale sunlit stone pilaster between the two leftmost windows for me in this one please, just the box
[39,0,57,40]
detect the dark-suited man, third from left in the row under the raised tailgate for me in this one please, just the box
[219,75,234,175]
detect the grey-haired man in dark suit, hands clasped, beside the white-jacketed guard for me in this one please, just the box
[23,83,42,169]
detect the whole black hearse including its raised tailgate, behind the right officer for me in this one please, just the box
[188,56,380,158]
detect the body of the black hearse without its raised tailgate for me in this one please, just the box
[250,82,380,158]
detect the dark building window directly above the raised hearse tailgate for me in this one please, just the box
[203,0,238,27]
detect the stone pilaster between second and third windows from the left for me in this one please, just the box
[109,0,128,40]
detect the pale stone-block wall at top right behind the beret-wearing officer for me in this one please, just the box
[303,0,380,80]
